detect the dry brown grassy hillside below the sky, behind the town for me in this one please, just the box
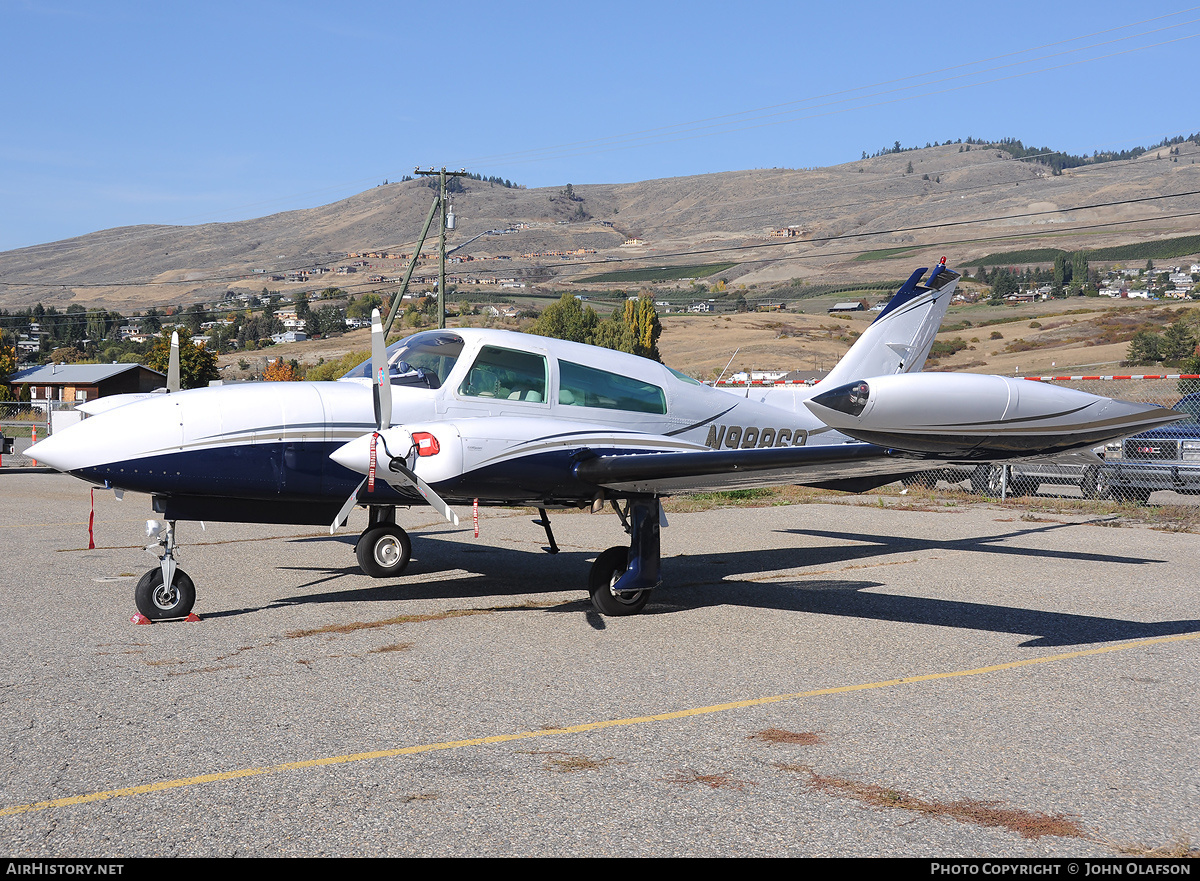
[0,144,1200,312]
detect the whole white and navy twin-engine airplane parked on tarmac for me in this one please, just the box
[29,258,1180,619]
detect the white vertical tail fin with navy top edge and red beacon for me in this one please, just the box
[821,257,959,388]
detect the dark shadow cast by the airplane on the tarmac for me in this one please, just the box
[208,525,1200,648]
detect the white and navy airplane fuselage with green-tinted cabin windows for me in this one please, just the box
[30,330,846,523]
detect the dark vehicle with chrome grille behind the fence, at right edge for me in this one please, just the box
[1099,392,1200,504]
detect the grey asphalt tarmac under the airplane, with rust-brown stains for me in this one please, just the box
[0,474,1200,858]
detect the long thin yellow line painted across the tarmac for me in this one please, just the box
[0,634,1200,816]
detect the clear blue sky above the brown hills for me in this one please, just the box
[0,0,1200,251]
